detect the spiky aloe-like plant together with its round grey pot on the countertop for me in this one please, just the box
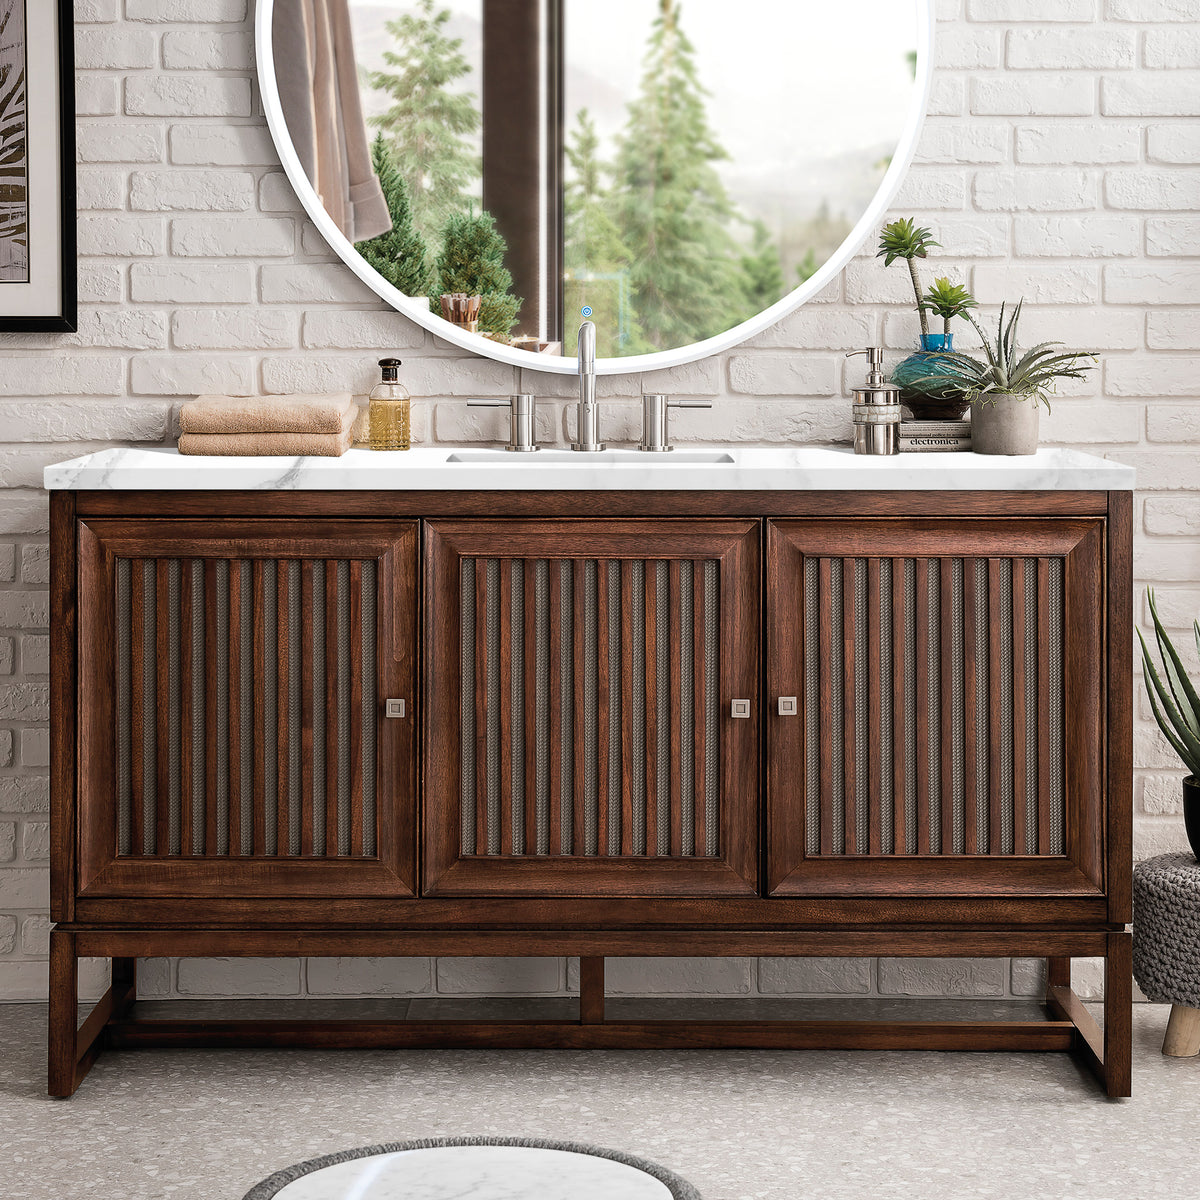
[907,301,1096,455]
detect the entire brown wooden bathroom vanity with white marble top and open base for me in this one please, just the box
[46,448,1133,1096]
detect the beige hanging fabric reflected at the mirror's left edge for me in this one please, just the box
[272,0,391,242]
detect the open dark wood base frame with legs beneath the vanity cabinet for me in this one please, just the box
[48,926,1133,1097]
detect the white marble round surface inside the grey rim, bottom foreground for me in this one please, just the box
[268,1146,671,1200]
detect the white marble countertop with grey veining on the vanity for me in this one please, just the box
[44,445,1134,492]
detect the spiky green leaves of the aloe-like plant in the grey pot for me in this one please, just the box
[914,301,1097,412]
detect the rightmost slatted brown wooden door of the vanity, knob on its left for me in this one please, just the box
[767,518,1104,896]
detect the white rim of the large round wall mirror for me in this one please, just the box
[254,0,935,374]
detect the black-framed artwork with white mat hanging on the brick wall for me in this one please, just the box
[0,0,77,331]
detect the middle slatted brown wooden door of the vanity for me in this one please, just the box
[424,520,760,896]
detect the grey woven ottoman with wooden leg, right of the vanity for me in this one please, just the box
[1133,853,1200,1057]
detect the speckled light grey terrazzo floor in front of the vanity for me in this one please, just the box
[0,1004,1200,1200]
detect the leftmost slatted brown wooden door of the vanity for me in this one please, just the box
[77,518,419,898]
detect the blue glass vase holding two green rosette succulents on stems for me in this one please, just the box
[876,217,974,421]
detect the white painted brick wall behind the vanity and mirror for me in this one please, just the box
[0,0,1200,998]
